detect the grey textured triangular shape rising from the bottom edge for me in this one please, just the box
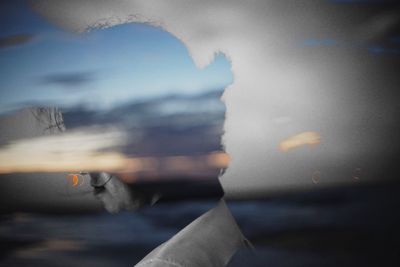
[136,200,244,267]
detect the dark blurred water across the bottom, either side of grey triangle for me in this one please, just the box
[0,183,400,266]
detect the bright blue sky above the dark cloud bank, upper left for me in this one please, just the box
[0,1,232,112]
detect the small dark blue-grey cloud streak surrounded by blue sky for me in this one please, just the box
[40,72,94,88]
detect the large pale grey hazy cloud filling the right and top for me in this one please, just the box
[32,0,400,197]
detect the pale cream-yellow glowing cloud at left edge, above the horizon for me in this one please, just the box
[0,128,125,173]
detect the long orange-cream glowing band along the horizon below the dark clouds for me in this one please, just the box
[0,133,229,181]
